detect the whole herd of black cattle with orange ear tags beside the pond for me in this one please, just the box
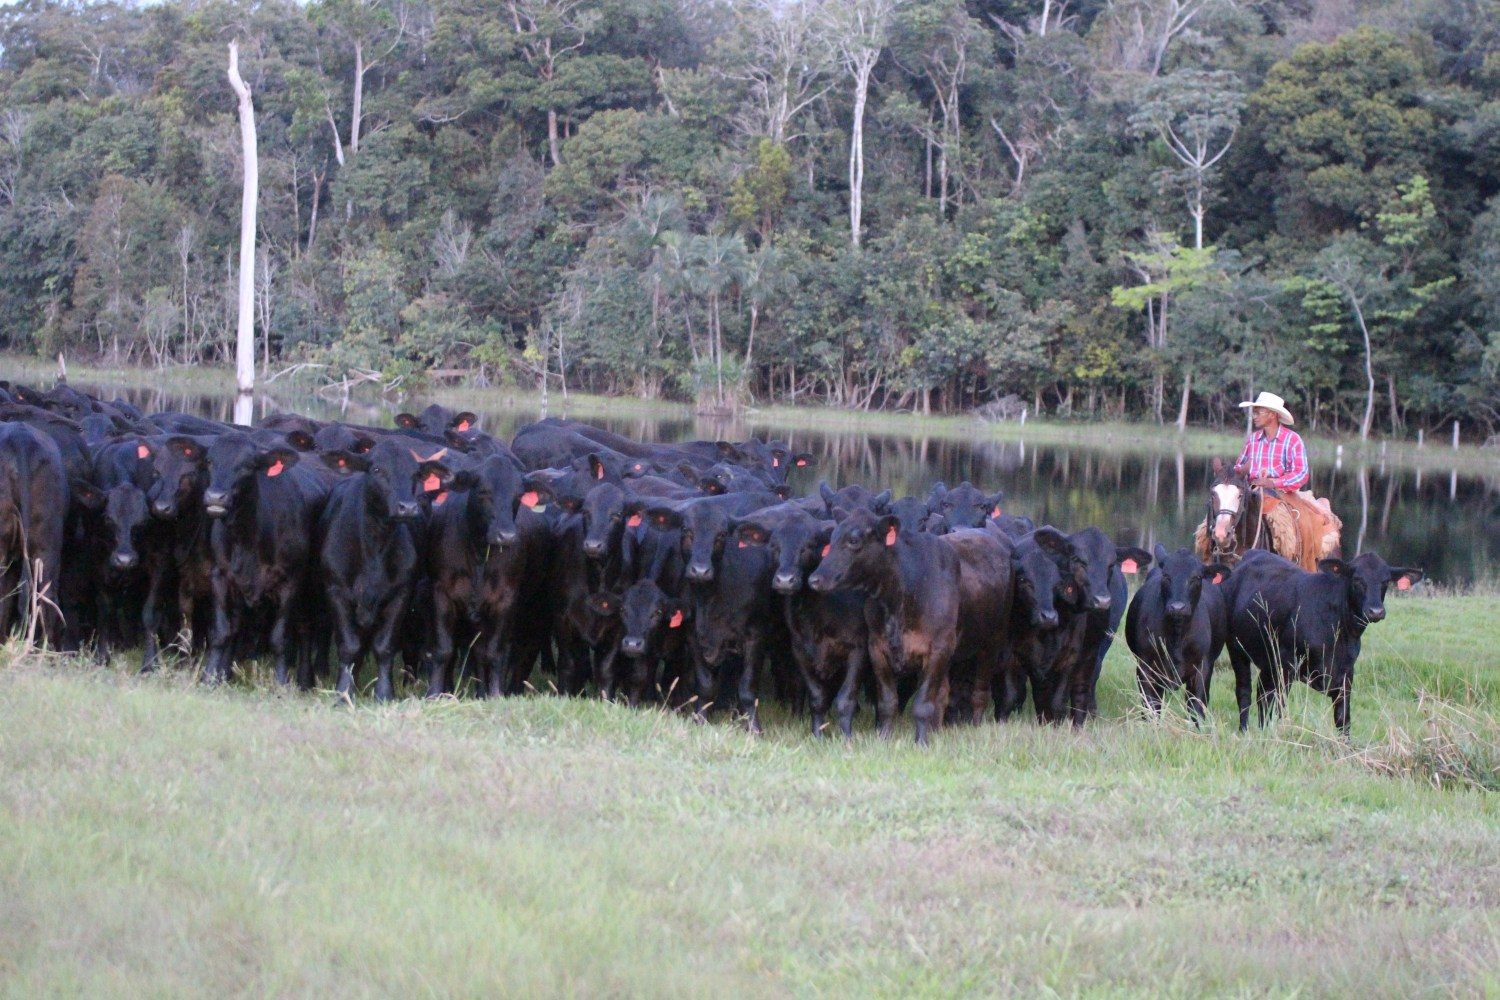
[0,381,1421,742]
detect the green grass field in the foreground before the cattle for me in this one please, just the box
[0,597,1500,997]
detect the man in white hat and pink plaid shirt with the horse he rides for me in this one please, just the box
[1197,391,1343,570]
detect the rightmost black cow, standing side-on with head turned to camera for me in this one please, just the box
[1229,550,1422,736]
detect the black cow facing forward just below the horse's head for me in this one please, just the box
[1125,543,1230,730]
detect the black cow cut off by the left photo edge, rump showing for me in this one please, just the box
[0,423,69,643]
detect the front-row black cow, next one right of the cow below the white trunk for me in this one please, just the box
[318,436,453,702]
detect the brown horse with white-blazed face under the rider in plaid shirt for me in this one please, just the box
[1194,459,1337,570]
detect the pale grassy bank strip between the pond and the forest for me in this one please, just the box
[11,355,1500,472]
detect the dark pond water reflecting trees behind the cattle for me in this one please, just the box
[80,385,1500,585]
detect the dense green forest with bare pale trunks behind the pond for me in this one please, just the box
[0,0,1500,435]
